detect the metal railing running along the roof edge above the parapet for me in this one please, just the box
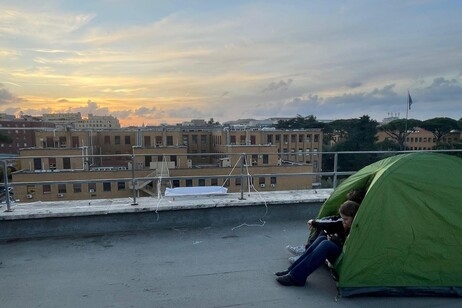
[0,150,462,211]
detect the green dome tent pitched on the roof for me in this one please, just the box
[319,153,462,296]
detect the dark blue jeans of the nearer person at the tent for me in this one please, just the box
[289,236,342,284]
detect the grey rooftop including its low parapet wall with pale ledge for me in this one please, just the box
[0,190,460,308]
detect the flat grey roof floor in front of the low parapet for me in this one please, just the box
[0,217,462,308]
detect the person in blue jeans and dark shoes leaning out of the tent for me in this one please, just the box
[275,200,359,286]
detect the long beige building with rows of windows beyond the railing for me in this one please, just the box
[13,126,322,201]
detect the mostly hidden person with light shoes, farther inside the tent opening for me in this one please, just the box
[286,188,366,264]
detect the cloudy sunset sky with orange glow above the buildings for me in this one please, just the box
[0,0,462,126]
